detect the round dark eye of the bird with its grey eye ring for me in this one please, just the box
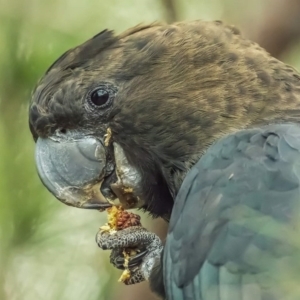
[88,86,115,109]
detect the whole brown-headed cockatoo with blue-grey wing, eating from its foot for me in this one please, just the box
[29,21,300,300]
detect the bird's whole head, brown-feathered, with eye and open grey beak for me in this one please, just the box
[29,21,292,219]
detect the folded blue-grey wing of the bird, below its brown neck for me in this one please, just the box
[164,124,300,300]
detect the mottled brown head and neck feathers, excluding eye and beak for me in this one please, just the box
[30,21,300,218]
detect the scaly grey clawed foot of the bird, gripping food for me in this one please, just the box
[96,226,163,285]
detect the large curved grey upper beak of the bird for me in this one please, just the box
[35,136,111,209]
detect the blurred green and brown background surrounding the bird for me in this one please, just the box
[0,0,300,300]
